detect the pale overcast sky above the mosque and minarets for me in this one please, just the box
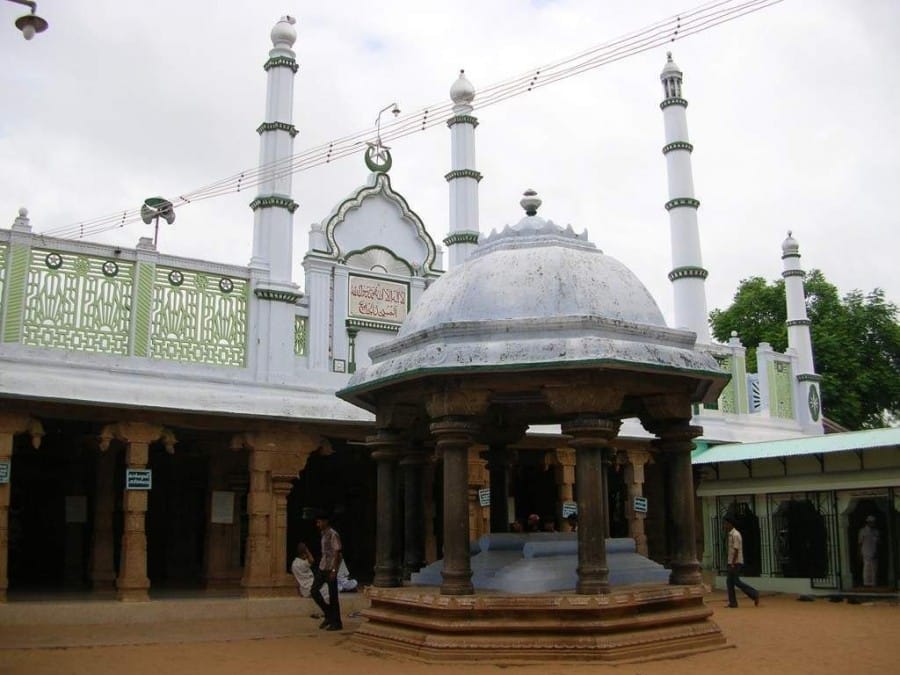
[0,0,900,323]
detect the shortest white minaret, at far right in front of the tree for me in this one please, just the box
[781,232,823,433]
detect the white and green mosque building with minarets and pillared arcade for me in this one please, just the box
[0,17,888,601]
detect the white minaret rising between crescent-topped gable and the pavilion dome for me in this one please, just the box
[444,70,481,269]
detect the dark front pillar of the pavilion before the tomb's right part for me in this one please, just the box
[562,415,620,595]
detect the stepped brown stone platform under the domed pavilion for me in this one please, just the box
[351,584,726,663]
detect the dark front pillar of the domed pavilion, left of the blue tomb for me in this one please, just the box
[431,416,478,595]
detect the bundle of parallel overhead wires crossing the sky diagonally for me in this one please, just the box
[42,0,783,243]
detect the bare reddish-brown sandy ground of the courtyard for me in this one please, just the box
[0,592,900,675]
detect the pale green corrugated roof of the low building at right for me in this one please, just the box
[691,428,900,464]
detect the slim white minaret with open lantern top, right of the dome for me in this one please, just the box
[659,52,710,344]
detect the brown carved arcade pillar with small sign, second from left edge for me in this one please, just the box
[99,422,175,602]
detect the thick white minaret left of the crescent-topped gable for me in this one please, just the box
[249,16,301,382]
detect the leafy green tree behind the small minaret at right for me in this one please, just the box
[710,270,900,429]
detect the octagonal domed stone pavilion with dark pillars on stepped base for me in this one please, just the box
[338,191,728,659]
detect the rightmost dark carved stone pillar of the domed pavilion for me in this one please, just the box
[654,420,703,584]
